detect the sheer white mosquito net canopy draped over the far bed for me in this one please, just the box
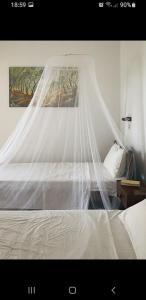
[0,55,126,209]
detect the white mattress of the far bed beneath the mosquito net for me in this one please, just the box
[0,162,116,193]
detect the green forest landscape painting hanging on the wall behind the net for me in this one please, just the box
[9,67,78,107]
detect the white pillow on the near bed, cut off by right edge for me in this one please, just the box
[119,199,146,259]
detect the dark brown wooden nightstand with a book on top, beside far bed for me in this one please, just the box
[117,180,146,209]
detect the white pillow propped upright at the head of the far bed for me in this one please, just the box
[103,143,126,178]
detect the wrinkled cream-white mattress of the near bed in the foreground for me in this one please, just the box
[0,210,136,259]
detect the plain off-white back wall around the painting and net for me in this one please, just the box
[0,41,120,161]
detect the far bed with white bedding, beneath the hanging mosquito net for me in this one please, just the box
[0,162,122,209]
